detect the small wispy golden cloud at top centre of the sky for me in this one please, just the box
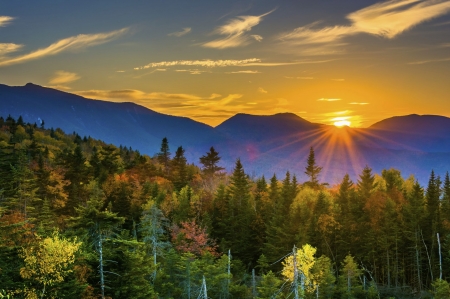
[202,10,273,49]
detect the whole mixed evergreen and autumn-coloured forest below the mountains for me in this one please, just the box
[0,116,450,299]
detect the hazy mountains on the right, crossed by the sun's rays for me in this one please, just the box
[216,113,450,184]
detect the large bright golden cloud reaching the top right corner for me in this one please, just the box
[280,0,450,50]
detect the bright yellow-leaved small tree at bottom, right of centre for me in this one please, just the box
[281,244,317,292]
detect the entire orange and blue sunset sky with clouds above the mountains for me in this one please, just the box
[0,0,450,127]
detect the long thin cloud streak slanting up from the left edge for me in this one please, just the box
[0,28,128,67]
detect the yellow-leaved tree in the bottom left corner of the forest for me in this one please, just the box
[20,232,81,298]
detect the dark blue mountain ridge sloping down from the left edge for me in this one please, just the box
[0,83,224,160]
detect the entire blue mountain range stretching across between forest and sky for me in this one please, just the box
[0,83,450,184]
